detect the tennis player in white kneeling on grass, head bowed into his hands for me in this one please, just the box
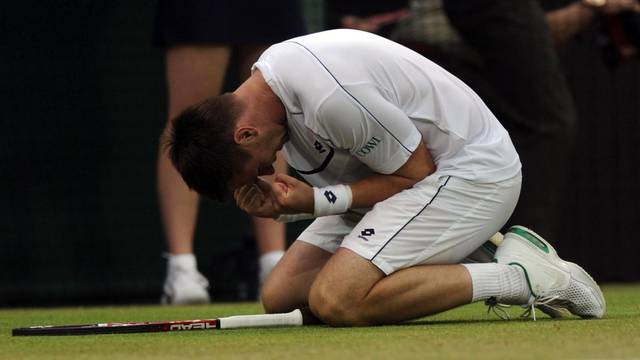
[169,29,605,326]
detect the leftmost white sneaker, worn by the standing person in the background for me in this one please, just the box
[160,267,211,305]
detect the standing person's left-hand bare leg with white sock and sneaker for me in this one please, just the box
[157,45,230,304]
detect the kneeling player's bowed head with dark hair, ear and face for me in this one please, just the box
[167,93,286,201]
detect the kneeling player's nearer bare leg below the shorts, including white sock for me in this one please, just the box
[309,248,530,326]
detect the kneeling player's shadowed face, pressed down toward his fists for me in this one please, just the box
[230,125,288,191]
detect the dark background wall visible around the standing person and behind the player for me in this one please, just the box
[0,0,640,306]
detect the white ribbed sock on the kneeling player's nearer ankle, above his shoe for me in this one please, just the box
[462,263,531,305]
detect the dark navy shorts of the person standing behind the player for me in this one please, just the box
[153,0,305,47]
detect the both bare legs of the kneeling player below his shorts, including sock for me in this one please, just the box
[262,228,529,325]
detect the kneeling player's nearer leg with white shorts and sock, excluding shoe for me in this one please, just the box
[309,176,529,325]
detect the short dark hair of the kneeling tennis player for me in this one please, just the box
[166,93,249,201]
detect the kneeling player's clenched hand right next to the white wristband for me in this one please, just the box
[272,174,313,214]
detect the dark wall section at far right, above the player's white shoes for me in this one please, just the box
[558,27,640,281]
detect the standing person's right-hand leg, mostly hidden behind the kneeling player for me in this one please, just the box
[238,45,288,285]
